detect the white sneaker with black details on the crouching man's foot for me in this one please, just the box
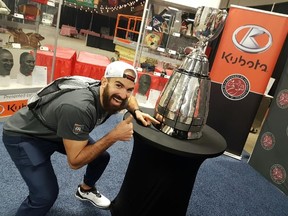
[75,185,111,209]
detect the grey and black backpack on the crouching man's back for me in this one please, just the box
[27,76,101,131]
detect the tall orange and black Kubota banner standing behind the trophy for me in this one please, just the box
[207,6,288,155]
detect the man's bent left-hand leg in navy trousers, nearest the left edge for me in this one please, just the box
[3,135,59,216]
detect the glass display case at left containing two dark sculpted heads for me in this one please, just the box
[0,1,58,119]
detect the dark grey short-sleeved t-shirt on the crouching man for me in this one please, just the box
[3,87,108,142]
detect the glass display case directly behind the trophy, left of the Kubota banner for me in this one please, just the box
[133,0,198,108]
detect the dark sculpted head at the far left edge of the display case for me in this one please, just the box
[0,49,14,87]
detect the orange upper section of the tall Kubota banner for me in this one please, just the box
[211,7,287,95]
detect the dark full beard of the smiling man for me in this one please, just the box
[102,85,128,114]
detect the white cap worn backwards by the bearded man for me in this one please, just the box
[104,61,137,83]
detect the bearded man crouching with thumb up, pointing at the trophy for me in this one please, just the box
[3,61,159,216]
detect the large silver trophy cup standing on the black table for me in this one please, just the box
[154,6,227,139]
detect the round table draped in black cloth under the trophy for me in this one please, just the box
[110,108,227,216]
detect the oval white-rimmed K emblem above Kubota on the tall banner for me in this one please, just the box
[232,25,272,53]
